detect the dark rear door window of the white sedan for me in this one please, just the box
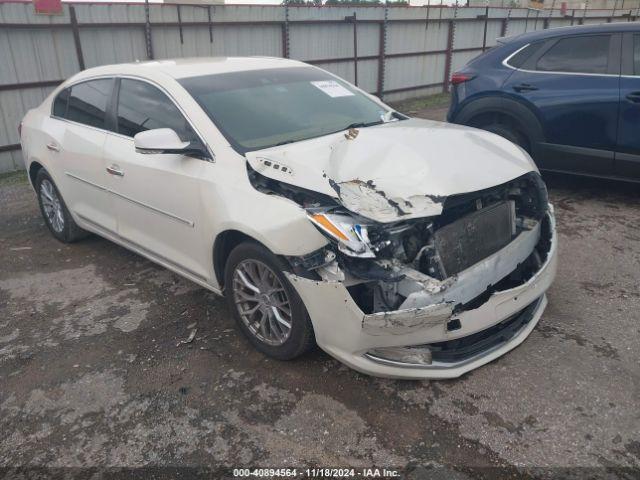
[65,79,113,128]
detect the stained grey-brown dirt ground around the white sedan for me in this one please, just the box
[0,99,640,479]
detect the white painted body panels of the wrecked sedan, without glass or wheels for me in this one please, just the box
[21,58,557,378]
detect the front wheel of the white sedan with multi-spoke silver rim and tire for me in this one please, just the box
[224,242,315,360]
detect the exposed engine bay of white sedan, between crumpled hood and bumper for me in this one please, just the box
[247,165,551,313]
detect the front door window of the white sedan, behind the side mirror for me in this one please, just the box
[118,78,197,142]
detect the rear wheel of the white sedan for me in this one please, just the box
[35,168,89,243]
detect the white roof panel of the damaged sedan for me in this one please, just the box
[74,57,308,80]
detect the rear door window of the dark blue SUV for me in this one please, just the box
[536,35,611,73]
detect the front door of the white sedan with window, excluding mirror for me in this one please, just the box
[105,78,211,281]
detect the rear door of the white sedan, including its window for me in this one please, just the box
[46,78,116,232]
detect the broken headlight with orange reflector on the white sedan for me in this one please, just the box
[307,211,376,258]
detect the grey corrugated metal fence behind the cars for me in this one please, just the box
[0,3,639,172]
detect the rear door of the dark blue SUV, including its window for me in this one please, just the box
[503,34,621,175]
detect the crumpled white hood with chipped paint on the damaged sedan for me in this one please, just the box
[246,119,536,222]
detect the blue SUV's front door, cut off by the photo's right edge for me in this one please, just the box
[615,33,640,180]
